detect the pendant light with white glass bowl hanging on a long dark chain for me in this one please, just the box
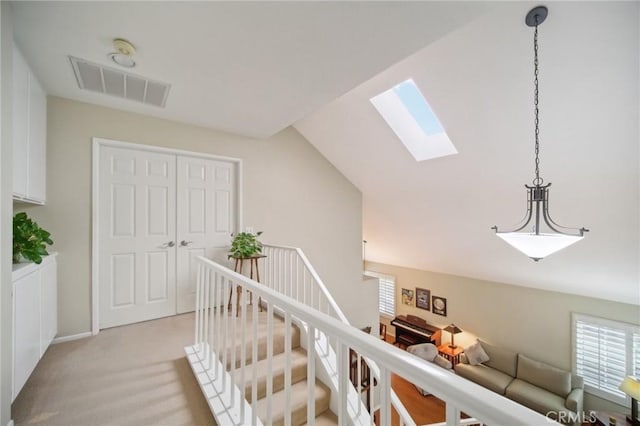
[492,6,589,262]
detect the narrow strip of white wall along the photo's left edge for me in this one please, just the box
[0,1,13,426]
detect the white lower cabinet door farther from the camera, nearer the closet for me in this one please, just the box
[40,259,58,357]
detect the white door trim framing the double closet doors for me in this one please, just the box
[91,138,242,336]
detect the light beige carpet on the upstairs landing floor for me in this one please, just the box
[11,314,215,426]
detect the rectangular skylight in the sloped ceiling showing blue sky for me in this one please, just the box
[371,79,458,161]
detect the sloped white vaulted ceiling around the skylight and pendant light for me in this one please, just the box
[295,2,640,304]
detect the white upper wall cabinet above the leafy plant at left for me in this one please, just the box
[13,45,47,204]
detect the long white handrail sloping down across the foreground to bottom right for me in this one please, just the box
[196,257,554,425]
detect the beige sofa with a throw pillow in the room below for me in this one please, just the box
[455,342,584,420]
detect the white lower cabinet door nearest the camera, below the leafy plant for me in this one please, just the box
[13,271,41,399]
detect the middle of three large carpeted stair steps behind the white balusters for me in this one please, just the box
[236,348,307,402]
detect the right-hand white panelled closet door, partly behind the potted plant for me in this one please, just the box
[177,156,236,313]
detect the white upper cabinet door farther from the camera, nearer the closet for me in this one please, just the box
[27,73,47,203]
